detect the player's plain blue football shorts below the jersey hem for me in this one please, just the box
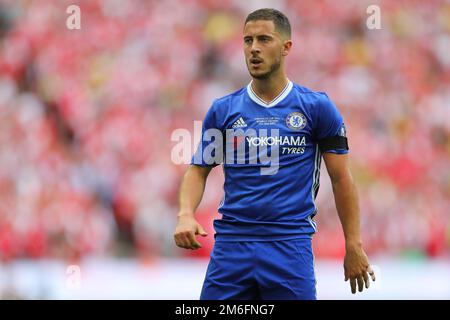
[200,238,316,300]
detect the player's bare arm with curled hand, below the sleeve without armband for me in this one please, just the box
[174,165,213,250]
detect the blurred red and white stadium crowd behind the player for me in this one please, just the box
[0,0,450,261]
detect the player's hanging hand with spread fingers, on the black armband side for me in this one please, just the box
[344,245,375,294]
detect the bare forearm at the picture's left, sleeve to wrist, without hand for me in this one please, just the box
[178,166,209,215]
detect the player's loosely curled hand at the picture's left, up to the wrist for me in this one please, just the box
[174,215,208,250]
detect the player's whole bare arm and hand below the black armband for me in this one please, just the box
[323,152,375,293]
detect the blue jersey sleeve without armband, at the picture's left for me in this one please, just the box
[191,102,223,167]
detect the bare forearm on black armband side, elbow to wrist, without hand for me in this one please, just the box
[332,174,361,246]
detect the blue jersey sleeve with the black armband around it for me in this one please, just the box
[315,93,348,154]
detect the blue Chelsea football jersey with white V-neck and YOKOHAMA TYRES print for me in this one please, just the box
[191,81,348,241]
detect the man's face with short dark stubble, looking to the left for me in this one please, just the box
[244,20,287,79]
